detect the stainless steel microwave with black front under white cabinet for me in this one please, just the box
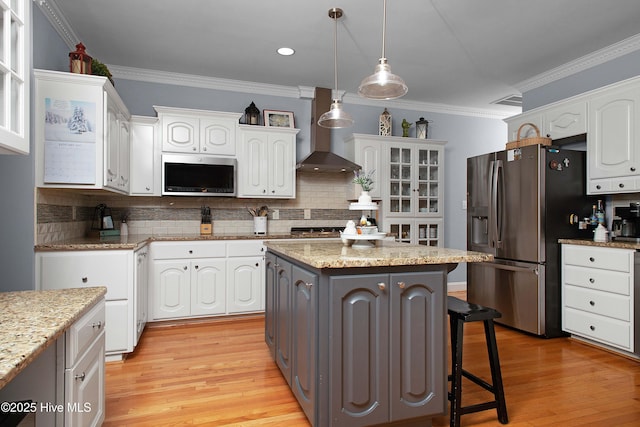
[162,154,237,197]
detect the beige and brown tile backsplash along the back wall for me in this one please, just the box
[35,173,360,244]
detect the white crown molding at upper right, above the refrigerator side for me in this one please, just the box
[515,34,640,93]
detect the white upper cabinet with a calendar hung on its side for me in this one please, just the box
[34,70,130,194]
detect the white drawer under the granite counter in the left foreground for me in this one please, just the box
[66,300,105,368]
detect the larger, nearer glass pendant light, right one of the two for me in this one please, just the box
[358,0,408,99]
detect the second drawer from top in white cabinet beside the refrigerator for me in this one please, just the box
[563,265,632,295]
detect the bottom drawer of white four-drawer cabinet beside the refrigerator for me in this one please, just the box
[563,308,633,351]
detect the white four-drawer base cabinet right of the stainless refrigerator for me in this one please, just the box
[562,244,640,353]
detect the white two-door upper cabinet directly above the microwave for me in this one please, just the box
[154,106,242,156]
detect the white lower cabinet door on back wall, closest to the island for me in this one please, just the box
[227,257,264,313]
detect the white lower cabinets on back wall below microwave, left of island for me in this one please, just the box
[149,241,264,320]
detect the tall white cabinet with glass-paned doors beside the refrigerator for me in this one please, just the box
[345,134,446,247]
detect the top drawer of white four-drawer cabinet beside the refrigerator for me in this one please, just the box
[563,245,633,273]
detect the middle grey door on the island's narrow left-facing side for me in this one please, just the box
[275,258,293,387]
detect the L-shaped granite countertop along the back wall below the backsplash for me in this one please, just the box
[34,232,340,252]
